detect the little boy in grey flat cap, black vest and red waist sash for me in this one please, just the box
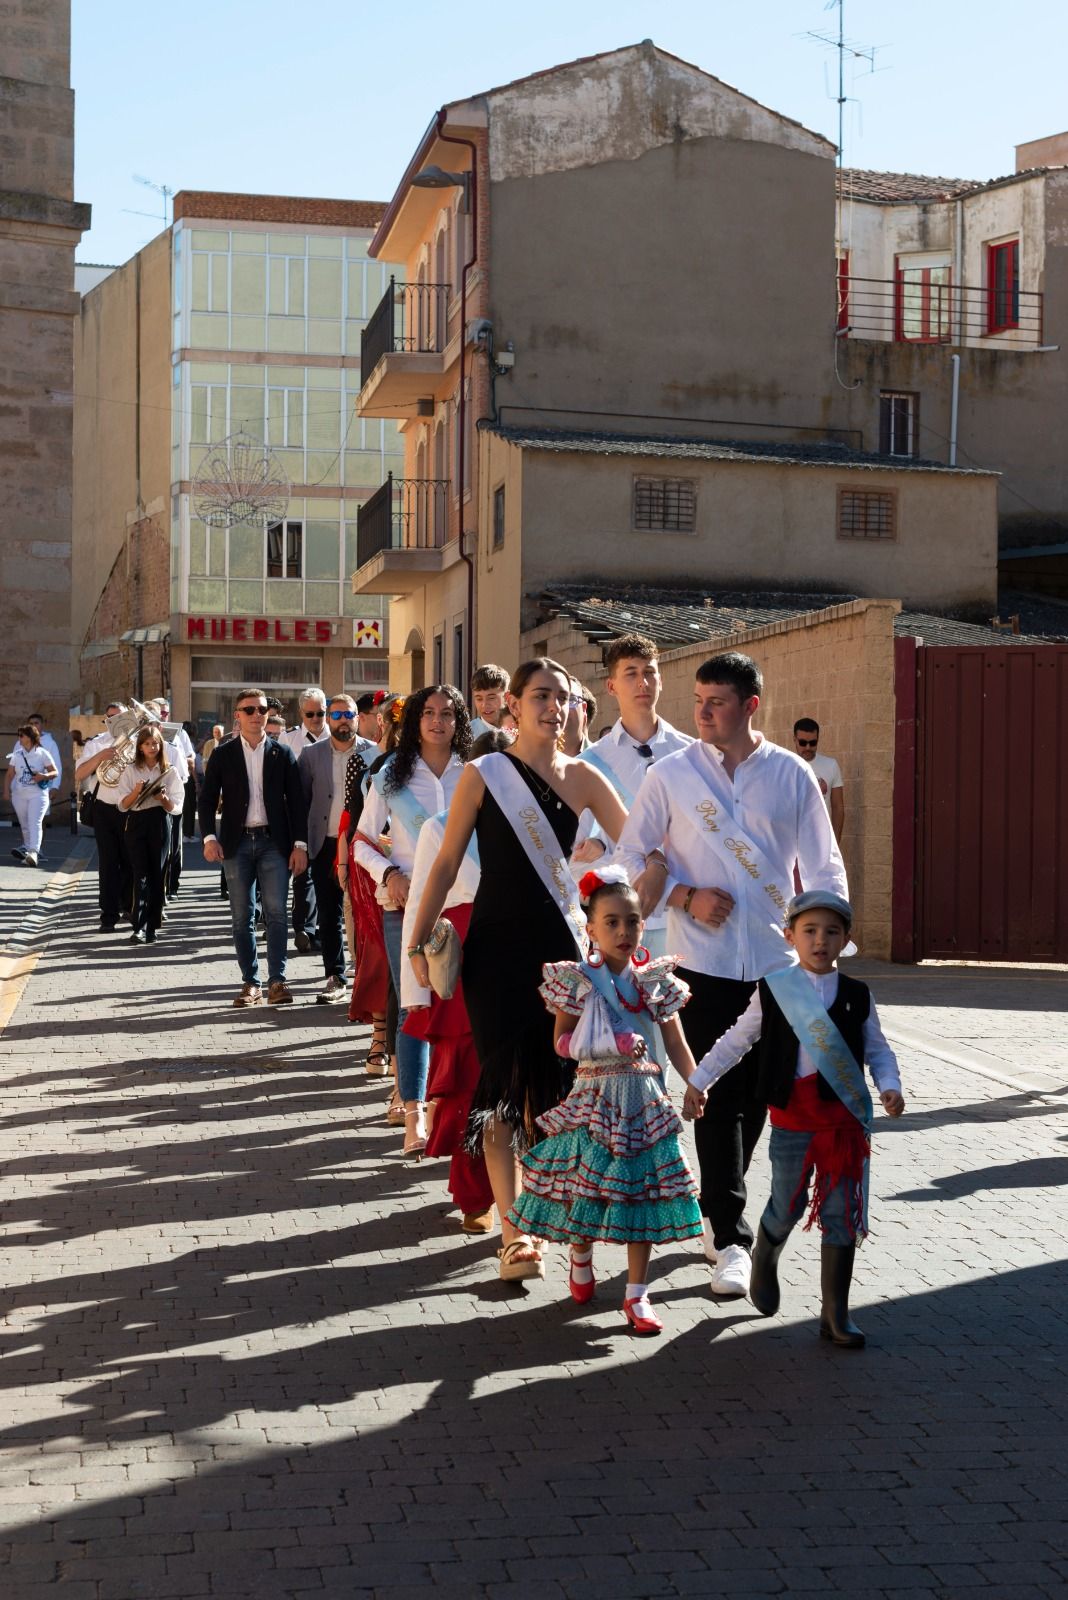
[686,890,905,1350]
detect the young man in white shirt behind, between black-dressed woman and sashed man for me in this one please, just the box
[571,634,694,955]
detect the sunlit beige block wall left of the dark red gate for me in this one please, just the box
[520,600,900,960]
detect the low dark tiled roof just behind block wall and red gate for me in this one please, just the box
[532,582,1068,650]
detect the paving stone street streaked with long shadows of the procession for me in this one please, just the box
[0,844,1068,1600]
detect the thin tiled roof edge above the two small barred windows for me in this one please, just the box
[489,426,983,475]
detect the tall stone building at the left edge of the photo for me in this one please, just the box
[0,0,90,774]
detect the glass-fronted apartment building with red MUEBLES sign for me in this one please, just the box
[72,192,400,730]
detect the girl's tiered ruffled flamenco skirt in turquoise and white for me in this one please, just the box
[508,1059,702,1245]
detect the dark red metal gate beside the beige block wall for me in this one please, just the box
[894,638,1068,962]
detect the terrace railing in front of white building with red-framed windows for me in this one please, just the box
[838,269,1044,349]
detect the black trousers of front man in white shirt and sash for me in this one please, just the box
[678,966,767,1250]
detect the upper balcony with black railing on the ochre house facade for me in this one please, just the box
[358,278,452,416]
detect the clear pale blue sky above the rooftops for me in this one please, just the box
[72,0,1068,262]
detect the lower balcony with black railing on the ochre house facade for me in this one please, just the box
[352,472,449,594]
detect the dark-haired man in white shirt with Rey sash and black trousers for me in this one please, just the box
[617,651,849,1296]
